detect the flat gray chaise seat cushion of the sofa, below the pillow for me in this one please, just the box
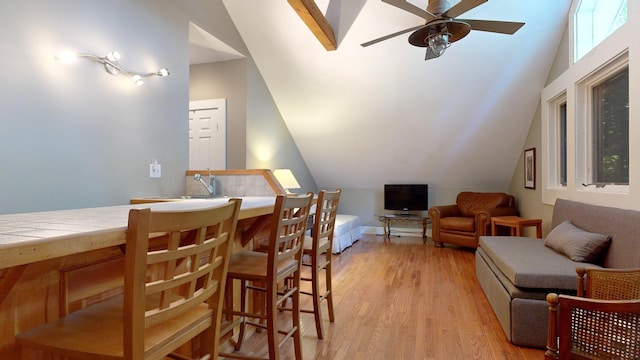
[480,236,598,290]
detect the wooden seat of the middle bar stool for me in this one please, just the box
[227,250,298,281]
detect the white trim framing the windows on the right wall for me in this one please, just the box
[539,0,640,209]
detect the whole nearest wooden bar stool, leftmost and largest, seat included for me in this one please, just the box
[16,199,241,360]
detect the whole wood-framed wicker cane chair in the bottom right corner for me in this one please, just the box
[545,268,640,360]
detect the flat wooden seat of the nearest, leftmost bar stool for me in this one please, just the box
[16,296,211,359]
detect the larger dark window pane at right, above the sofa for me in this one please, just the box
[593,68,629,184]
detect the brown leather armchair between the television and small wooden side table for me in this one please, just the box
[429,192,518,248]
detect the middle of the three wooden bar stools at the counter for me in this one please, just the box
[220,193,313,360]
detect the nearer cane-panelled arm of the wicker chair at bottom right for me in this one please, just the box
[545,294,640,359]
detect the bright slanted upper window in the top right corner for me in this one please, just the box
[574,0,627,62]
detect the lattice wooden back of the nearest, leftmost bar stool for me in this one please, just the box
[123,199,241,359]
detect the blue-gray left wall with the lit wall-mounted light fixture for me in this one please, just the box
[0,0,315,213]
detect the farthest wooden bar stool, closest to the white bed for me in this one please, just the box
[300,189,341,339]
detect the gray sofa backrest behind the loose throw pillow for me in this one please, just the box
[551,199,640,268]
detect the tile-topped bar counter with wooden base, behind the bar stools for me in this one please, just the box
[0,197,275,359]
